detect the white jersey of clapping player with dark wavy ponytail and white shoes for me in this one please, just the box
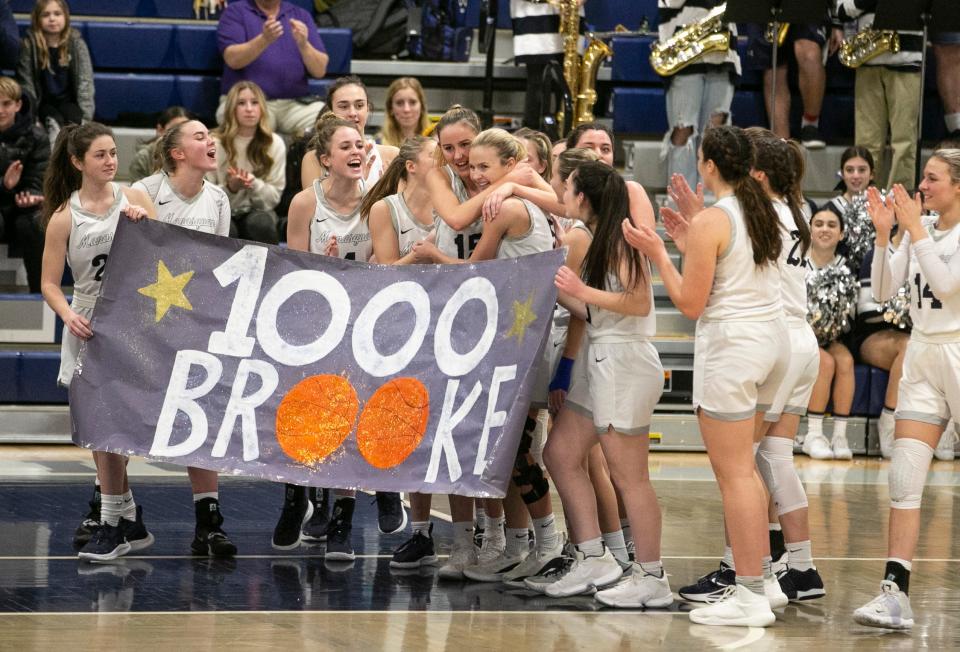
[700,195,783,321]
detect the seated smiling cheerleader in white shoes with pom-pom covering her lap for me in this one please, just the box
[803,210,854,460]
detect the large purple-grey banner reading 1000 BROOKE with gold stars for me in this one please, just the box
[70,220,563,497]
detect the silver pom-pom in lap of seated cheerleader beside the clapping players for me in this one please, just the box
[807,263,860,346]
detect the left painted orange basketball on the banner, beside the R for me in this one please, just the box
[276,375,360,466]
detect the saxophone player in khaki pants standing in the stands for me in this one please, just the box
[837,0,928,188]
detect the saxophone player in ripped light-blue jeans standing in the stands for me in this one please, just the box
[657,0,740,188]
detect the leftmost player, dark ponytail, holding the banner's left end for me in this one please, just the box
[41,122,155,561]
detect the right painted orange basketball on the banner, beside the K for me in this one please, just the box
[357,378,430,469]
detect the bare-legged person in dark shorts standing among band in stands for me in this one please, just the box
[746,22,843,149]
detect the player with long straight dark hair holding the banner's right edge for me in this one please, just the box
[544,161,673,608]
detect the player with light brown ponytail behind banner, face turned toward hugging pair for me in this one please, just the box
[360,136,437,265]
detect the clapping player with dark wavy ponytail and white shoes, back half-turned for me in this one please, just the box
[623,126,790,627]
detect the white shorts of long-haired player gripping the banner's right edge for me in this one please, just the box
[564,340,663,435]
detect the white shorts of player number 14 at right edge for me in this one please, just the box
[896,338,960,427]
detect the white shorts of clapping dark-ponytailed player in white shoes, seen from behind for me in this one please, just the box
[693,318,790,421]
